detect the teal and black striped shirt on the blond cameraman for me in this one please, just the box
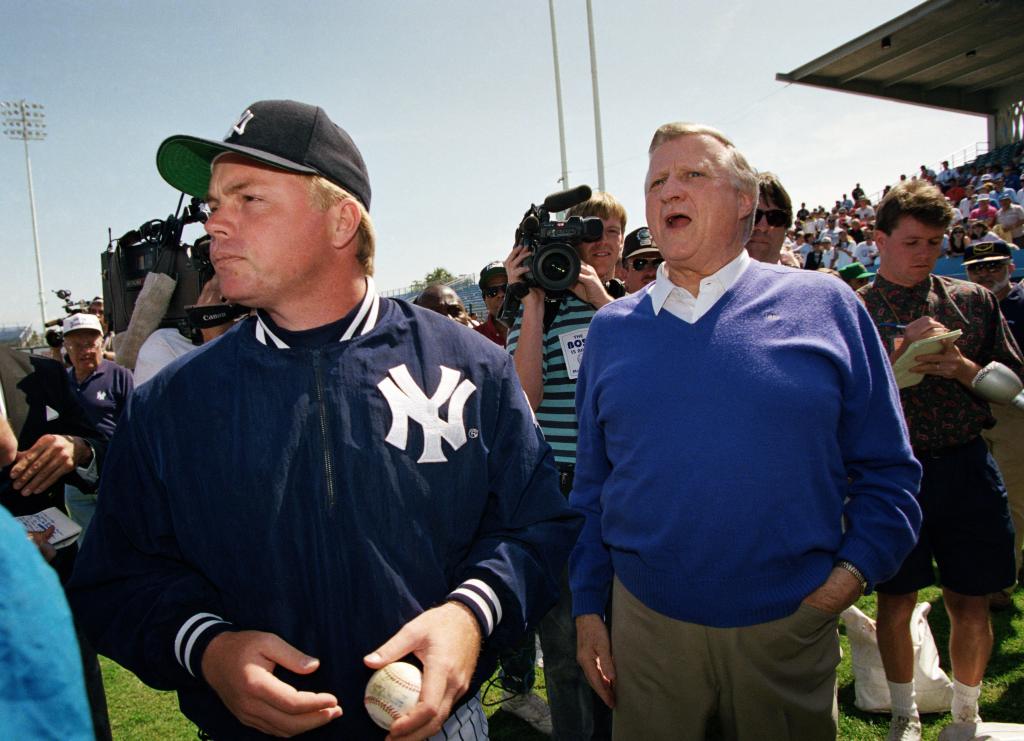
[507,296,596,464]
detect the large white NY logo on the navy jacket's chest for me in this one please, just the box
[377,364,476,463]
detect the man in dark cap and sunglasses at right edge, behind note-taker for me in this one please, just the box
[964,242,1024,610]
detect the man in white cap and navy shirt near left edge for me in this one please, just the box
[63,313,134,538]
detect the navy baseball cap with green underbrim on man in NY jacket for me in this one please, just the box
[157,100,370,210]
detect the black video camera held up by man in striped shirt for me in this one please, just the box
[498,185,604,326]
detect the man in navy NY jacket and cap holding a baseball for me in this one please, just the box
[70,100,579,741]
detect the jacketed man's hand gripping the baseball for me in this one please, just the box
[365,602,481,741]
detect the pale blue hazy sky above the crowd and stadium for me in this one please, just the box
[0,0,985,325]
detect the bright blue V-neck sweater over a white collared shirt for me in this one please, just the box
[570,262,921,627]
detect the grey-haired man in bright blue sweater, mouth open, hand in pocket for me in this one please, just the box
[569,124,921,740]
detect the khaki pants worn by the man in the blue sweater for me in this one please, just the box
[611,579,840,741]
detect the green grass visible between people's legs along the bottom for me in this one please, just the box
[101,589,1024,741]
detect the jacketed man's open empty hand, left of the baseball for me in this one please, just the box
[203,630,341,737]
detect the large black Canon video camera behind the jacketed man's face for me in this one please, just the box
[99,195,213,336]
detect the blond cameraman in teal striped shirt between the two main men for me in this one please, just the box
[505,192,626,738]
